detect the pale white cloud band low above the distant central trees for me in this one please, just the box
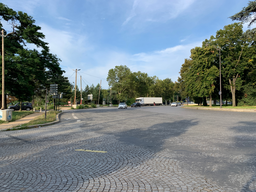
[66,41,202,89]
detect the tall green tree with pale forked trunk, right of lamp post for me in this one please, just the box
[211,23,255,106]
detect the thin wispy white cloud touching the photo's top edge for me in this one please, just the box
[123,0,195,25]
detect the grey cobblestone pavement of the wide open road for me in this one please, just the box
[0,107,256,192]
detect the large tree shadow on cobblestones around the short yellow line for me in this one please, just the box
[0,110,198,191]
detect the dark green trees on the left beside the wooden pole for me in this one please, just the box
[0,3,71,107]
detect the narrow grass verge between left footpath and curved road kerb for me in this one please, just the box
[6,111,60,131]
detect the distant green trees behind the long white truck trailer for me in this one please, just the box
[107,65,175,104]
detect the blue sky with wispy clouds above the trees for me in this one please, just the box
[1,0,252,89]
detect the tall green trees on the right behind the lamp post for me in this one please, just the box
[176,1,256,106]
